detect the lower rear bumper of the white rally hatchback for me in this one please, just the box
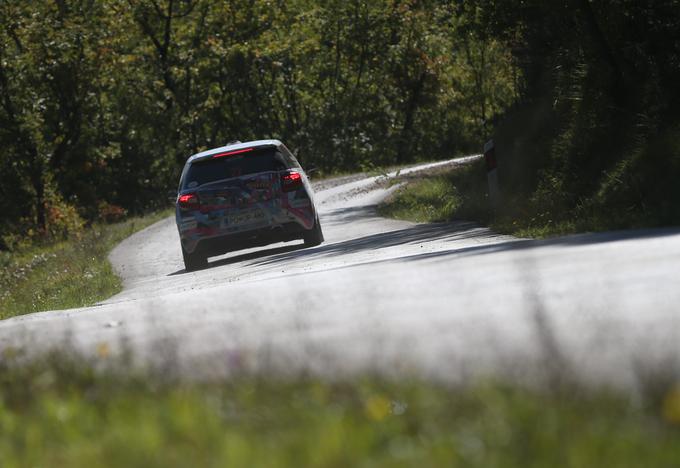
[182,222,306,257]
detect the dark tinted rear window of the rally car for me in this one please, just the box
[183,148,286,188]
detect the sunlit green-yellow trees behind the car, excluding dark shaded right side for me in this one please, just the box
[0,0,518,248]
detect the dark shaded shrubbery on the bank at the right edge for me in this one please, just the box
[486,0,680,230]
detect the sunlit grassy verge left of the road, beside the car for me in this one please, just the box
[0,210,170,319]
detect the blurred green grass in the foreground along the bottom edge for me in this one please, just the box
[0,350,680,468]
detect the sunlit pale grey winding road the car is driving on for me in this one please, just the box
[0,160,680,388]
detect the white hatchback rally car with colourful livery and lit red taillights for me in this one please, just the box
[175,140,324,271]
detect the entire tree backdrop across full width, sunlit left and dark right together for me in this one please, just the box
[0,0,680,248]
